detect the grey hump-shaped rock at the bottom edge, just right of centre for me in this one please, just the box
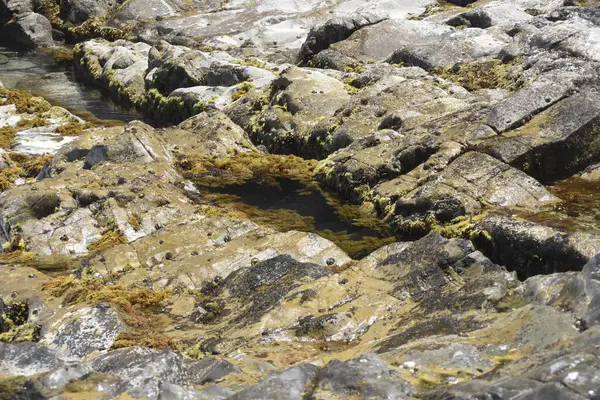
[313,354,414,399]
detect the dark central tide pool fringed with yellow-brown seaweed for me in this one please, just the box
[197,178,396,259]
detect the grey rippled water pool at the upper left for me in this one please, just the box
[0,47,140,122]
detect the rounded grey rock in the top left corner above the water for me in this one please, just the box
[2,13,54,49]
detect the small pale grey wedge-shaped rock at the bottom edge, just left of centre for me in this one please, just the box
[231,364,317,400]
